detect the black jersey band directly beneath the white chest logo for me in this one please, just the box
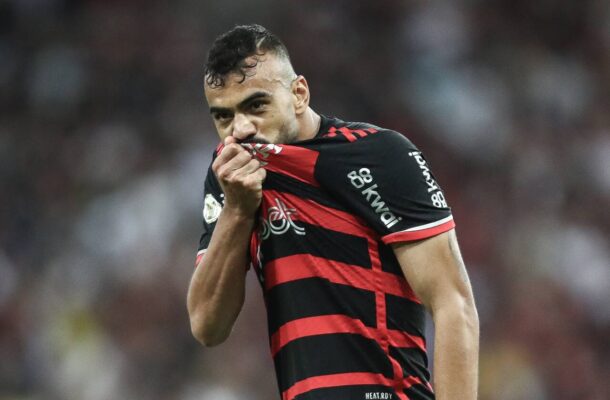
[261,221,371,268]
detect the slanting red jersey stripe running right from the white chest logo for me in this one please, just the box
[263,190,372,238]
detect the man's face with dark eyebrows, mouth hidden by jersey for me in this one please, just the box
[205,53,298,144]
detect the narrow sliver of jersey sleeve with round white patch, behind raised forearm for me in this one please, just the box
[195,159,224,265]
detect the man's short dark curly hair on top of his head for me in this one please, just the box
[204,24,290,87]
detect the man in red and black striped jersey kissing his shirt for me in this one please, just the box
[187,25,478,400]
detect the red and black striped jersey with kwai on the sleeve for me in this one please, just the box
[198,117,455,400]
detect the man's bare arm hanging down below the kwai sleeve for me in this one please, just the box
[393,229,479,400]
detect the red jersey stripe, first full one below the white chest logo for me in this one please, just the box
[265,254,420,304]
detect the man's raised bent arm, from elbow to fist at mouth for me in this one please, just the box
[187,137,265,346]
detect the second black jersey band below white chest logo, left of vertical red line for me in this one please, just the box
[265,278,376,335]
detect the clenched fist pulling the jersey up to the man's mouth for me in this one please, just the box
[212,136,266,216]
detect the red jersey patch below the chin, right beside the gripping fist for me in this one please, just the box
[259,145,320,186]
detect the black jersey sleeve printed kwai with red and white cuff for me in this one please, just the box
[316,131,455,244]
